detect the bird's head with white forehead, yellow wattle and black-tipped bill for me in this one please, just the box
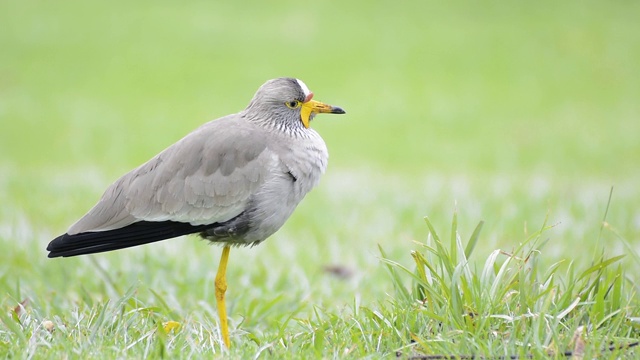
[245,78,345,129]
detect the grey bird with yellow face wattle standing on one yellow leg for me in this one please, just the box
[47,77,346,349]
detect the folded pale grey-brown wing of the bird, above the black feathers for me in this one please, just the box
[68,119,281,234]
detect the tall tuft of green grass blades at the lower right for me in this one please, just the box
[380,213,640,358]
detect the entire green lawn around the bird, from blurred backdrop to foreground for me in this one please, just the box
[0,0,640,359]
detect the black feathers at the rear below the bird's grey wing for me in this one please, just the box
[47,221,217,258]
